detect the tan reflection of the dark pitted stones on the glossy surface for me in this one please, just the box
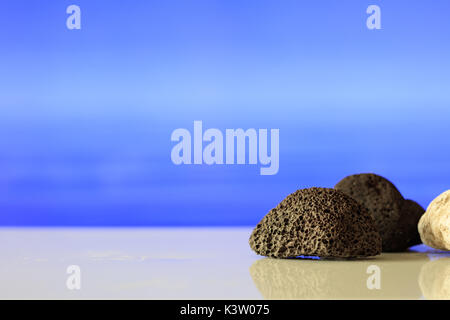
[250,252,428,299]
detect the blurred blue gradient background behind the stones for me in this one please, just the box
[0,0,450,226]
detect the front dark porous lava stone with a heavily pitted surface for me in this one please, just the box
[249,188,381,258]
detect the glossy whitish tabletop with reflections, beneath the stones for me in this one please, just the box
[0,228,450,299]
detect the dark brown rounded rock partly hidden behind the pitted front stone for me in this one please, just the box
[335,173,425,252]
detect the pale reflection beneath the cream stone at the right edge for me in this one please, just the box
[419,253,450,300]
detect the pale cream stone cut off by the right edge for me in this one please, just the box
[419,190,450,250]
